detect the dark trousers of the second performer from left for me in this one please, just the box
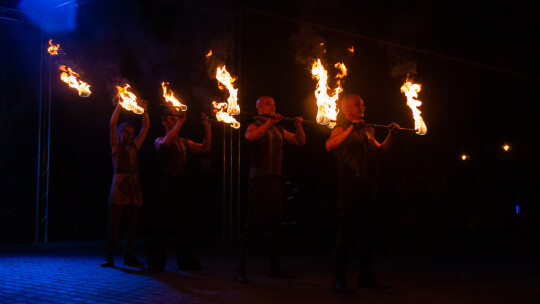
[148,176,198,270]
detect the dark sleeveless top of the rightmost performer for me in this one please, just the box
[334,123,378,183]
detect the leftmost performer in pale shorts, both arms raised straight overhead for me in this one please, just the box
[101,101,150,267]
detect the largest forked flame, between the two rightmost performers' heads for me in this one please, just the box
[311,59,347,128]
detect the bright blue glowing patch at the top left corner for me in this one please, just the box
[19,0,77,33]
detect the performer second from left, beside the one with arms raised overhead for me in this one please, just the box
[148,112,211,272]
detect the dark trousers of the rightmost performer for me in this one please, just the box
[335,179,375,282]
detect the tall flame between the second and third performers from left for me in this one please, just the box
[212,65,240,129]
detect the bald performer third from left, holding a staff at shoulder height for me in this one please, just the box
[235,96,306,283]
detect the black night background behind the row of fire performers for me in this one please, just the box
[0,0,540,253]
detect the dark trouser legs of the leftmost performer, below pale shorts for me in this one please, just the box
[107,204,140,257]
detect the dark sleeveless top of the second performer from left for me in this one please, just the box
[157,136,189,176]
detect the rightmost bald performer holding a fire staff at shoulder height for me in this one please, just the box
[326,95,399,292]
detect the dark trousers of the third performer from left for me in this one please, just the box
[240,175,284,271]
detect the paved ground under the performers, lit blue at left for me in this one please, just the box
[0,242,540,304]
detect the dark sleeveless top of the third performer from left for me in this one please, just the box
[248,119,283,180]
